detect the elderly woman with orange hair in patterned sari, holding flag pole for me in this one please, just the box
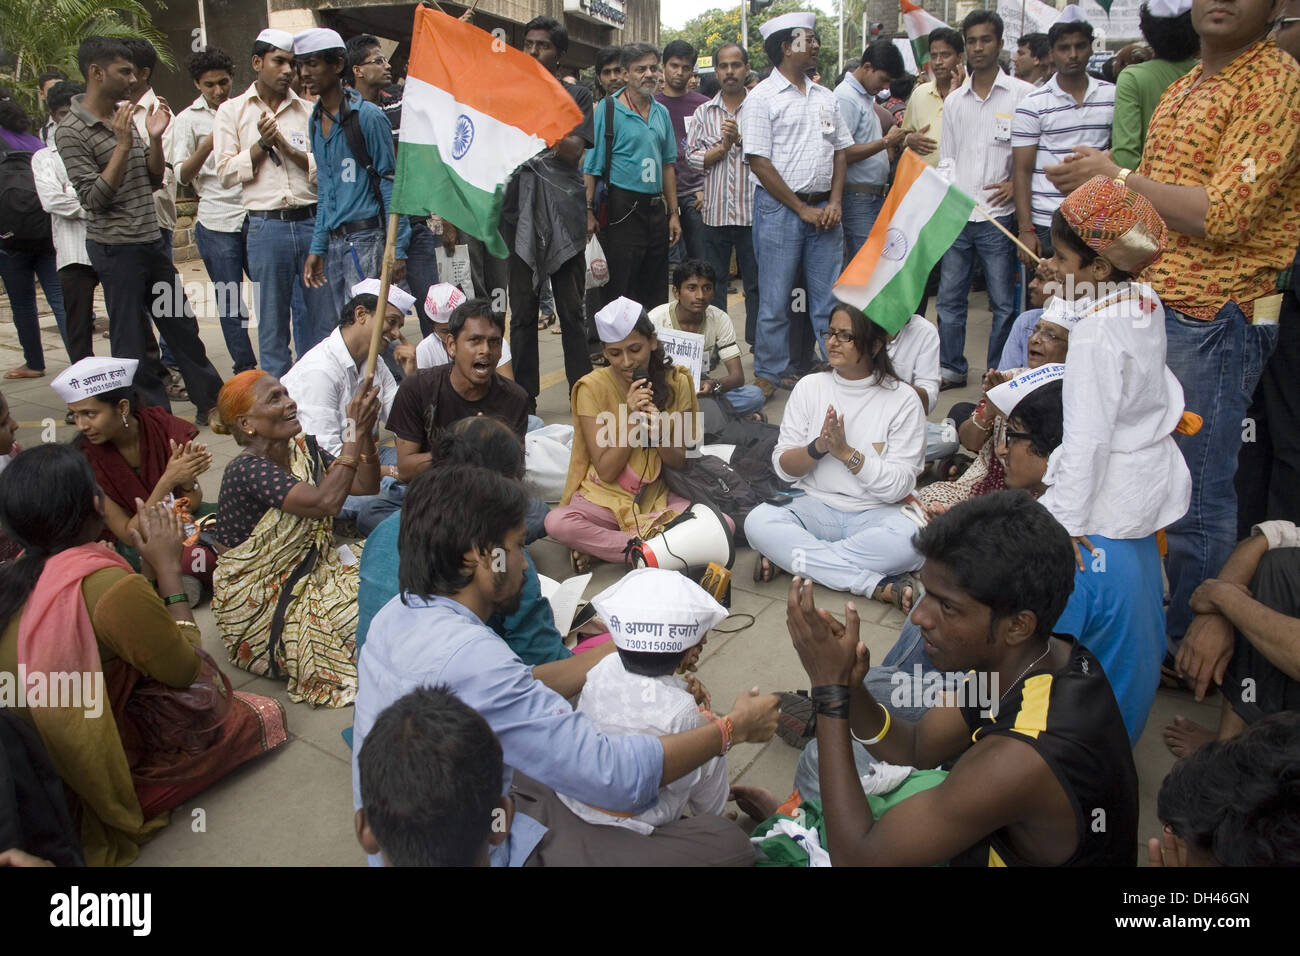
[212,369,380,708]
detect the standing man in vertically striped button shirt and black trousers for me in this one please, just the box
[686,43,758,345]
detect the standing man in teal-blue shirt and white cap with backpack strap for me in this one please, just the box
[294,27,411,316]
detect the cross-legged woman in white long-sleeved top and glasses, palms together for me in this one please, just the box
[745,302,926,597]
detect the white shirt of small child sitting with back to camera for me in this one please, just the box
[559,653,731,836]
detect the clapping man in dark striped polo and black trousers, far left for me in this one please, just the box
[55,36,221,425]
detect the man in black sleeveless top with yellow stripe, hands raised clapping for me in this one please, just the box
[736,492,1138,866]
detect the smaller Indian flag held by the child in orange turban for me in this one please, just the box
[835,150,975,334]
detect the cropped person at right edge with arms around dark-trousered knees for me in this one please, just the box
[1165,522,1300,757]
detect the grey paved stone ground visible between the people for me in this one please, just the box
[0,260,1218,866]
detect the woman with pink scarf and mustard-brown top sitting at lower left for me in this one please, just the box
[0,444,286,866]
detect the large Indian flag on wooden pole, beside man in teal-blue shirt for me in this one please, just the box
[390,7,582,258]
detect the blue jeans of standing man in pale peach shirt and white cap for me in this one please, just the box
[247,216,338,378]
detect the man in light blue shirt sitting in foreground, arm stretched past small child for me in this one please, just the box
[352,464,776,865]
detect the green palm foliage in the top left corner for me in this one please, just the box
[0,0,172,117]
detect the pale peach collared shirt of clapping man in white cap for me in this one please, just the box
[212,83,316,209]
